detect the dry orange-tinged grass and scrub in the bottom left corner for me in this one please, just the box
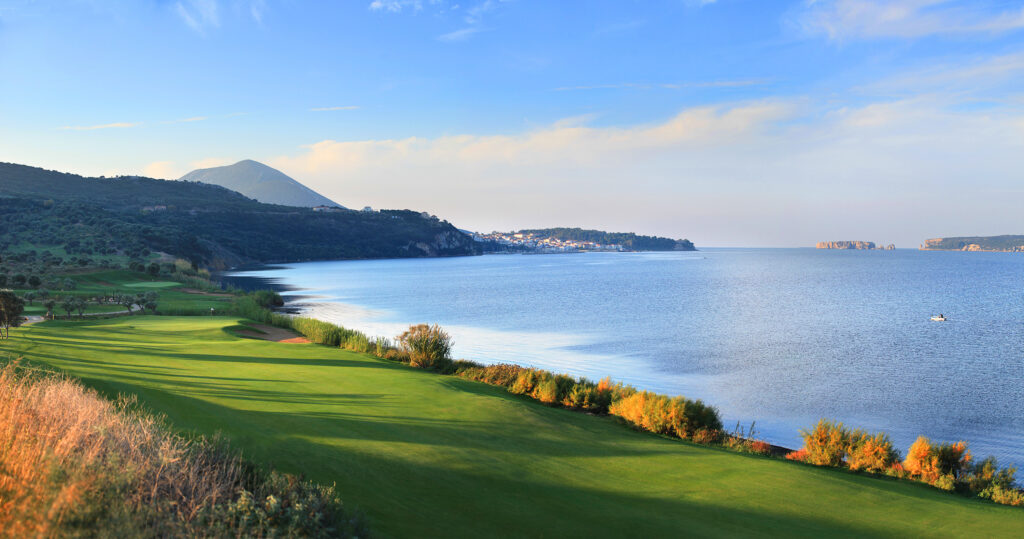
[0,361,367,538]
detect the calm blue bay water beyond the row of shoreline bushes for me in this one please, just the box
[230,249,1024,467]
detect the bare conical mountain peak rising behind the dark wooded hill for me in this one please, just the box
[180,159,341,208]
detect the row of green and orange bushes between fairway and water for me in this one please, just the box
[234,291,1024,507]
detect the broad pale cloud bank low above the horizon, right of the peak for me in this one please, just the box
[268,98,1024,247]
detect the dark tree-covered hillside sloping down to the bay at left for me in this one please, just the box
[0,163,478,267]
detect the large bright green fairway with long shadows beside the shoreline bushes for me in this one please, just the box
[0,316,1024,537]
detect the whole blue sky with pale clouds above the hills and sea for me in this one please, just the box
[0,0,1024,247]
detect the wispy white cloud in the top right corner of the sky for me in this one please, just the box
[798,0,1024,40]
